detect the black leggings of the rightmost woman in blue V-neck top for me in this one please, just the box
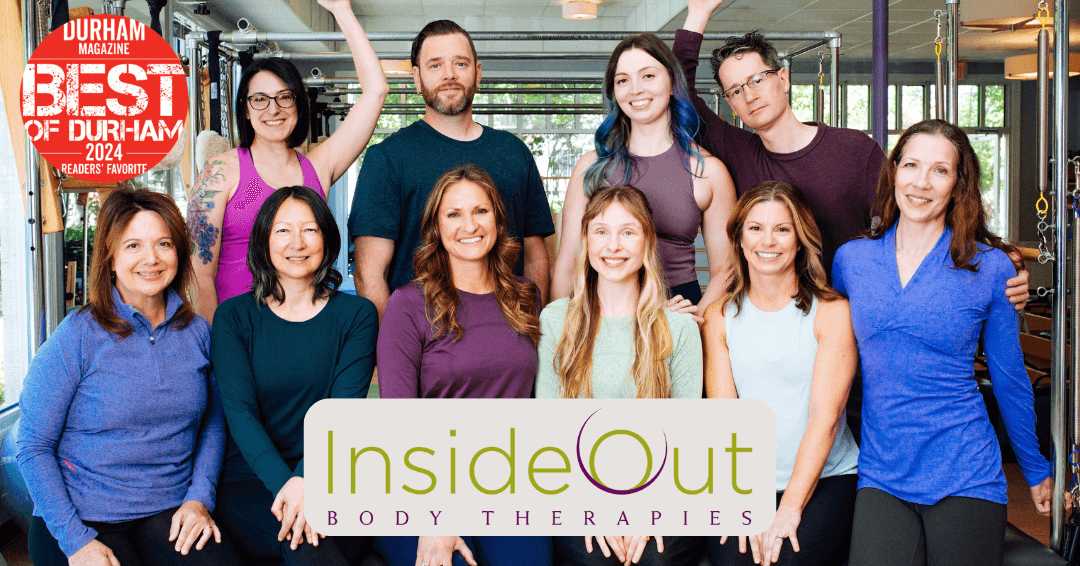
[849,487,1007,566]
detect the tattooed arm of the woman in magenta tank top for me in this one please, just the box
[188,152,239,324]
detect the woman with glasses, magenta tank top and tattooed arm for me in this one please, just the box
[188,0,388,322]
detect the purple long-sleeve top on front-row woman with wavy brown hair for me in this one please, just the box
[376,281,540,399]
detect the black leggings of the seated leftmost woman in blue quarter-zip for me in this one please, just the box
[26,508,241,566]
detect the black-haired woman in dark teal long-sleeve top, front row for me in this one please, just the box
[214,187,378,565]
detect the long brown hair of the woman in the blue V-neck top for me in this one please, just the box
[866,120,1022,271]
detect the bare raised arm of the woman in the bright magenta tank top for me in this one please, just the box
[308,0,390,187]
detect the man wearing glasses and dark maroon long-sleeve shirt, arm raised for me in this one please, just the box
[674,0,885,271]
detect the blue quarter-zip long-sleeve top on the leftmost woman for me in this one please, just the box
[17,288,226,556]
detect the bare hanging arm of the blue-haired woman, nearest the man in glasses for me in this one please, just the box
[694,156,735,312]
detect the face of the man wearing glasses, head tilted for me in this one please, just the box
[717,52,791,130]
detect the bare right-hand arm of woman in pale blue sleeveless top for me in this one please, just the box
[760,299,859,564]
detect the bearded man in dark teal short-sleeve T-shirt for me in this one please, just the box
[349,19,555,316]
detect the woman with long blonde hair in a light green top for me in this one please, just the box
[537,185,702,565]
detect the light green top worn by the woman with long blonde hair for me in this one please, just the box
[537,298,702,399]
